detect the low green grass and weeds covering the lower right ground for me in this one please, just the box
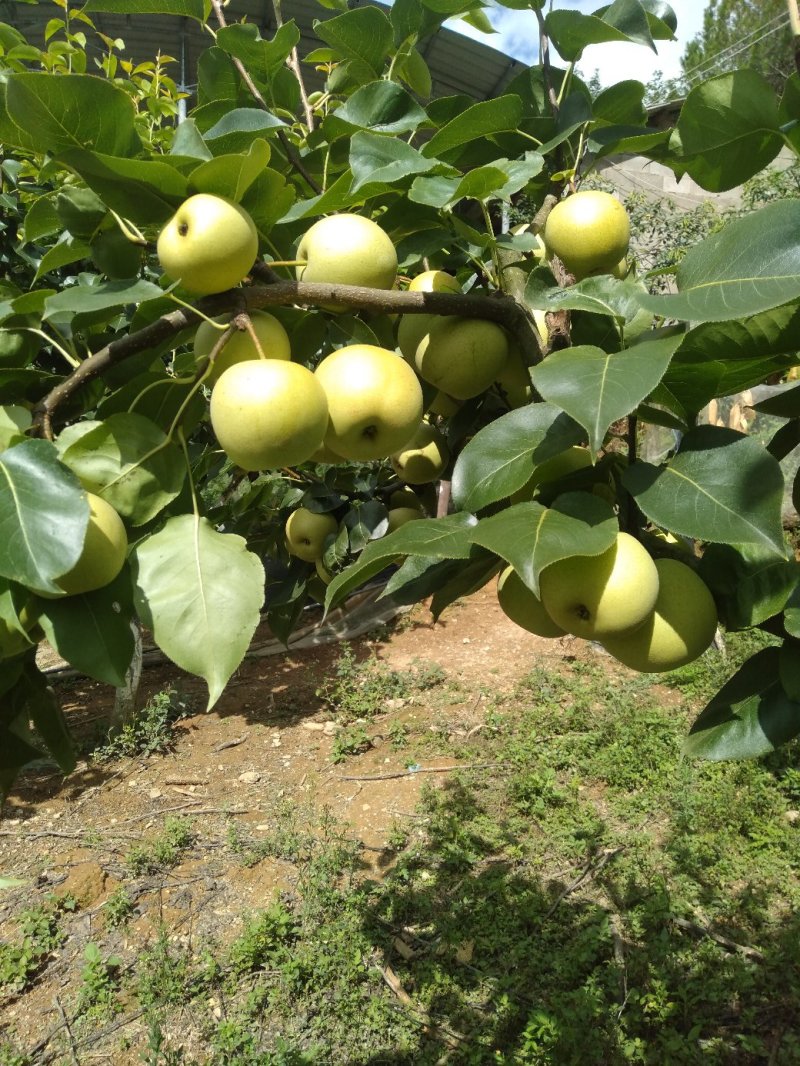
[0,639,800,1066]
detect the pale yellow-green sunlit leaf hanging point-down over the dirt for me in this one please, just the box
[132,515,265,709]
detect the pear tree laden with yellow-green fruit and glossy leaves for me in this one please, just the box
[0,0,800,794]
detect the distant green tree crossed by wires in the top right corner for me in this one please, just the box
[681,0,795,92]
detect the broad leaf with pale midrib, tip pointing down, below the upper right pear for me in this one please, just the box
[531,337,681,454]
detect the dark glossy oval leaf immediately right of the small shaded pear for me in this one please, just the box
[451,403,585,513]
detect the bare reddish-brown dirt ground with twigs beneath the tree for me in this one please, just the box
[0,585,614,1062]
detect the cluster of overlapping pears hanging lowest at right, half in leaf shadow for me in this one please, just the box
[497,447,718,673]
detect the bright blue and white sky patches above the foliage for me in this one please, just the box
[447,0,706,87]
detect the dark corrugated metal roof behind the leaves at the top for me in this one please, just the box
[0,0,533,100]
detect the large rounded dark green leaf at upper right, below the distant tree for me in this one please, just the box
[677,68,783,192]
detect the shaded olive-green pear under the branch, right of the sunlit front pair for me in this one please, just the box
[414,317,509,400]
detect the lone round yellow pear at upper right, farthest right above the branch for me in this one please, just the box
[543,189,630,279]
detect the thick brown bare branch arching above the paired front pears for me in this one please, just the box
[33,281,541,439]
